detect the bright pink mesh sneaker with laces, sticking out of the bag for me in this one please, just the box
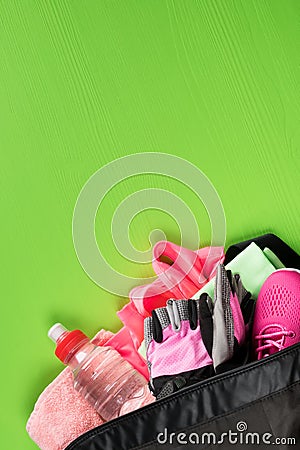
[253,269,300,359]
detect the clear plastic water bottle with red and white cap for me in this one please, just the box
[48,323,154,421]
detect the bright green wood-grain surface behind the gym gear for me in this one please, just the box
[0,0,300,450]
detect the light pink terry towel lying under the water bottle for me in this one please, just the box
[26,330,153,450]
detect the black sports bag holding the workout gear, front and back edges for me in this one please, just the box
[66,235,300,450]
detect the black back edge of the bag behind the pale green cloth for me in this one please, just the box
[224,233,300,269]
